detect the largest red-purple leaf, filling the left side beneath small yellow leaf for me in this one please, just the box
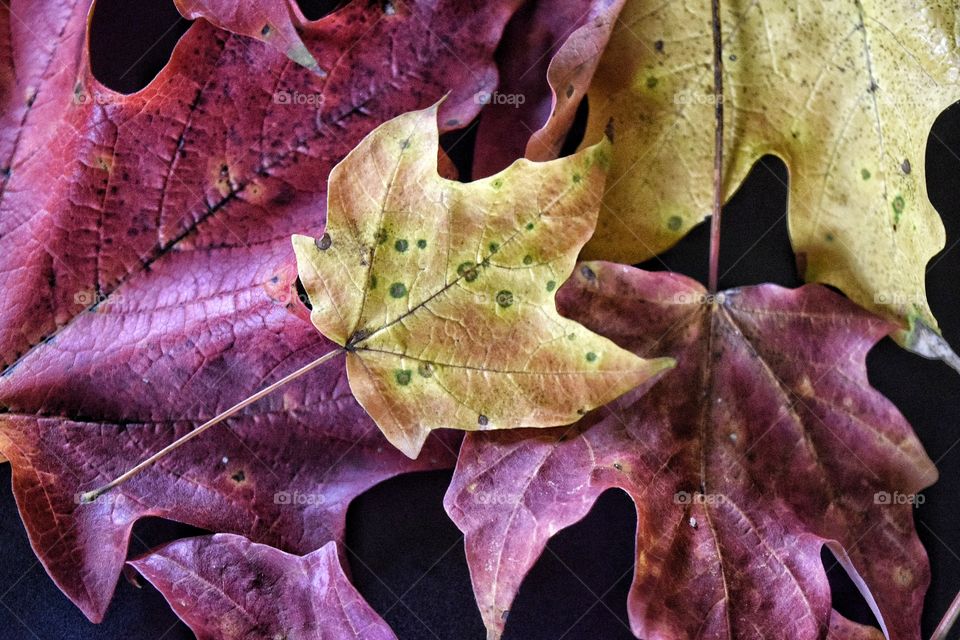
[0,0,517,620]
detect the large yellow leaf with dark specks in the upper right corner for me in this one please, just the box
[584,0,960,355]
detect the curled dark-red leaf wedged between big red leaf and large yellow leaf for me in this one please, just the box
[473,0,625,177]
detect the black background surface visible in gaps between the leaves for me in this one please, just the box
[0,0,960,640]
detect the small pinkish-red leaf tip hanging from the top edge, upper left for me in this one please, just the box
[174,0,326,75]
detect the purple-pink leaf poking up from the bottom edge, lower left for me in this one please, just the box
[130,534,396,640]
